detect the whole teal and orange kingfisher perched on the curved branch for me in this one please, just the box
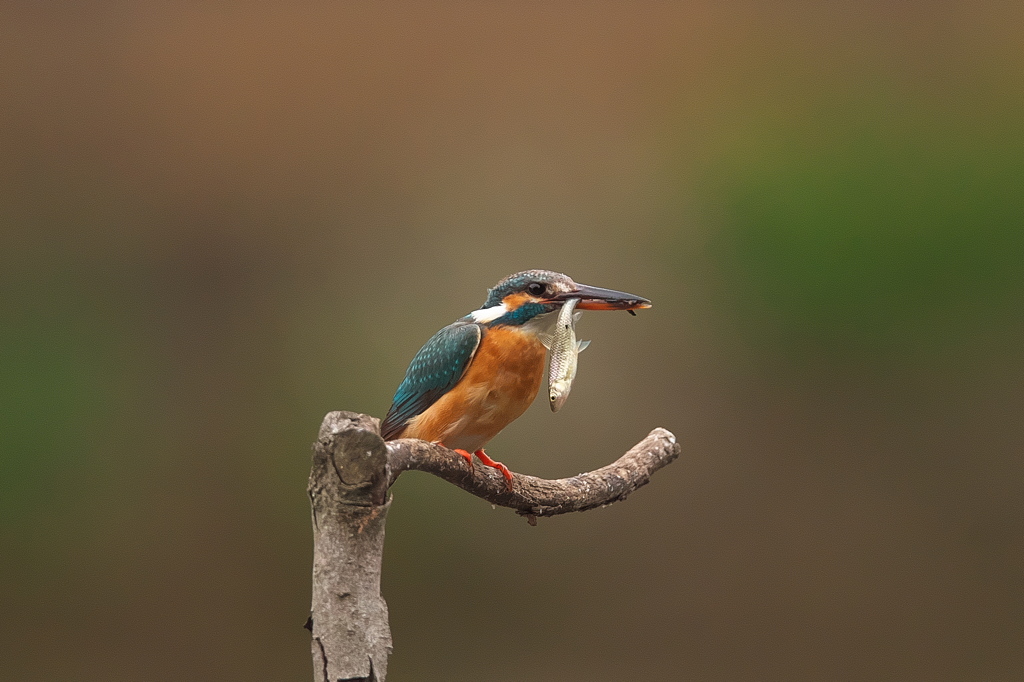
[381,270,650,487]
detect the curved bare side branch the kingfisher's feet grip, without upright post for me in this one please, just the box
[387,428,680,518]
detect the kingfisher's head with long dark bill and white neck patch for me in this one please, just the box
[470,270,650,325]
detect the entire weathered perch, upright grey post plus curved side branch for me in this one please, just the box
[307,405,680,682]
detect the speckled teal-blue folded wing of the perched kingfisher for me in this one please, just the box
[381,319,483,440]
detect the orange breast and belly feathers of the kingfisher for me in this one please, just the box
[402,327,546,452]
